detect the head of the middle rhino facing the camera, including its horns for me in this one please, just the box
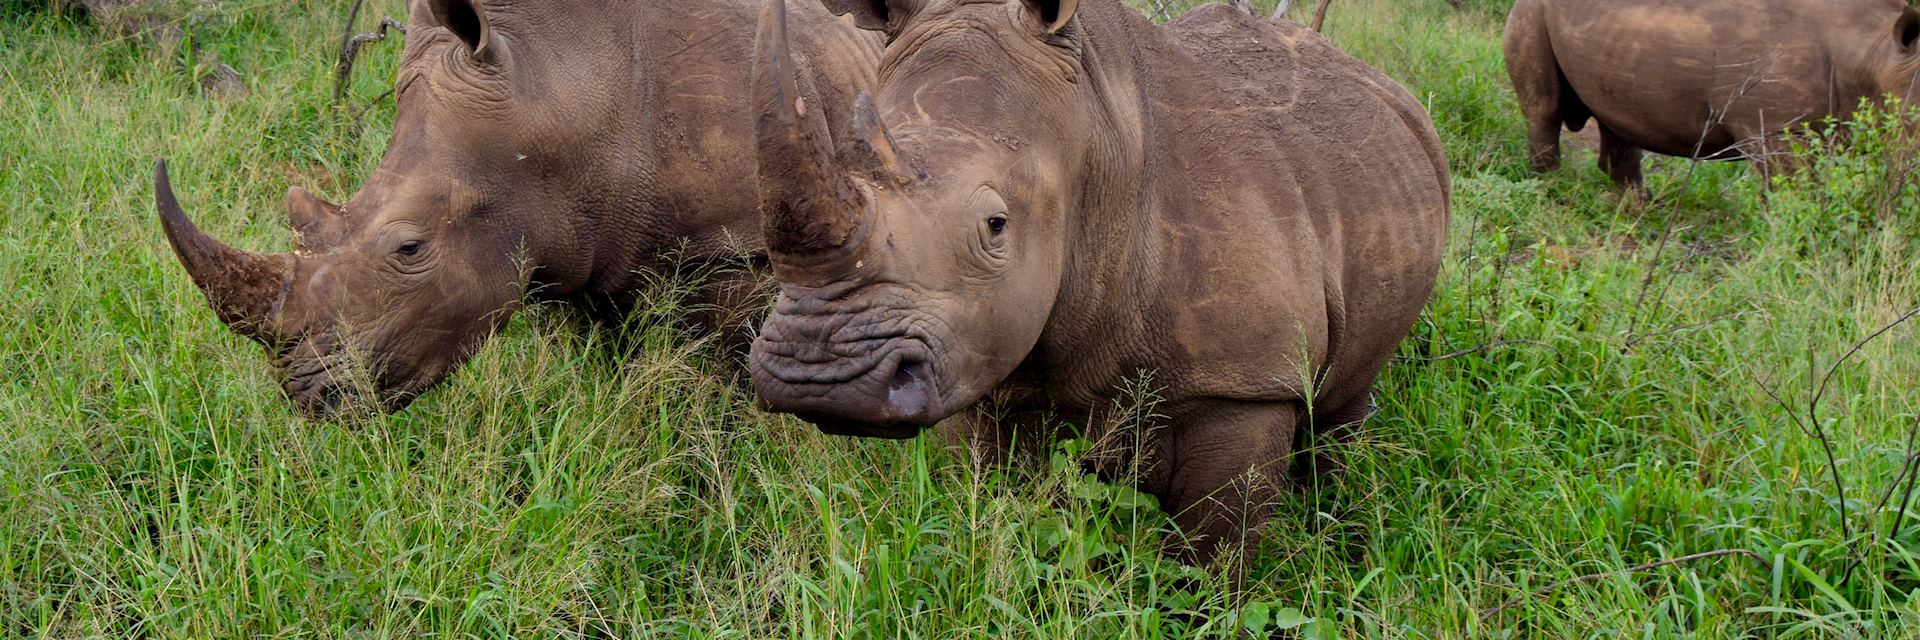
[749,0,1112,438]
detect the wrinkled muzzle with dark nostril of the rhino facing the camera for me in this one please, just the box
[749,297,948,434]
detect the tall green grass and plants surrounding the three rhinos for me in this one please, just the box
[0,0,1920,638]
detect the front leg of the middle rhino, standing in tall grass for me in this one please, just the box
[1146,400,1300,575]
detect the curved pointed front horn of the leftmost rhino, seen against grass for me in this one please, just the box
[154,160,294,342]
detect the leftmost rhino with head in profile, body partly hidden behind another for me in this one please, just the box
[156,0,881,417]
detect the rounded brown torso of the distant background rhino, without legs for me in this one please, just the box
[1546,0,1889,156]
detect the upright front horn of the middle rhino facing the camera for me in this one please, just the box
[753,0,866,258]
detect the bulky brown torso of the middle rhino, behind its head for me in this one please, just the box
[1121,6,1450,402]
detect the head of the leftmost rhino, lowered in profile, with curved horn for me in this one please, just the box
[156,0,618,417]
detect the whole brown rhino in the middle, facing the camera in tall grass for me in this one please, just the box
[749,0,1450,561]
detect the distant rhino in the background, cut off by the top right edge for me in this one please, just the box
[1505,0,1920,190]
